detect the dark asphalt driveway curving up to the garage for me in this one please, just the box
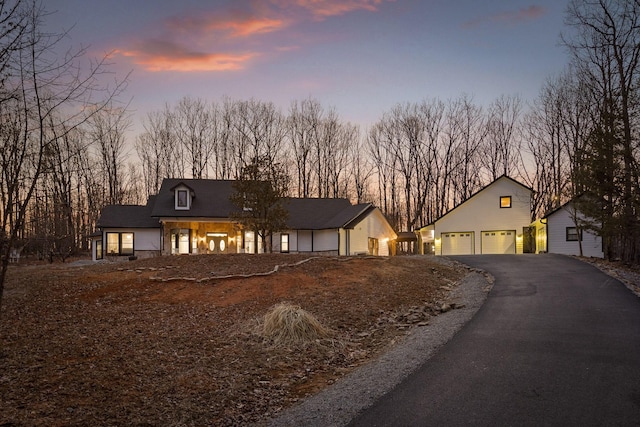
[350,254,640,426]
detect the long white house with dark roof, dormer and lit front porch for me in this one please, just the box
[93,179,397,259]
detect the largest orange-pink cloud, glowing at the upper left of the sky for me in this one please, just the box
[118,0,395,72]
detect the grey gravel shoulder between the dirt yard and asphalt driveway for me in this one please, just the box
[258,258,493,427]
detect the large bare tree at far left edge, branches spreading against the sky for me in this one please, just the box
[0,2,127,316]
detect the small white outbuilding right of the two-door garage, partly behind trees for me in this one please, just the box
[534,201,604,258]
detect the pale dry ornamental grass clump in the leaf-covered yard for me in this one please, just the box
[262,303,330,347]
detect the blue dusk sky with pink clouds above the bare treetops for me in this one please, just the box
[44,0,568,142]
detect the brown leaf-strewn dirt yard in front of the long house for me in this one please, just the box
[0,254,466,426]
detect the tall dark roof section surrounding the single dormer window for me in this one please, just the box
[151,178,236,218]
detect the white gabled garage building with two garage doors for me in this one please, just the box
[417,175,532,255]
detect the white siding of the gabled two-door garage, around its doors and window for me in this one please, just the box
[435,177,531,255]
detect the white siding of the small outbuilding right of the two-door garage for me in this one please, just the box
[547,203,604,258]
